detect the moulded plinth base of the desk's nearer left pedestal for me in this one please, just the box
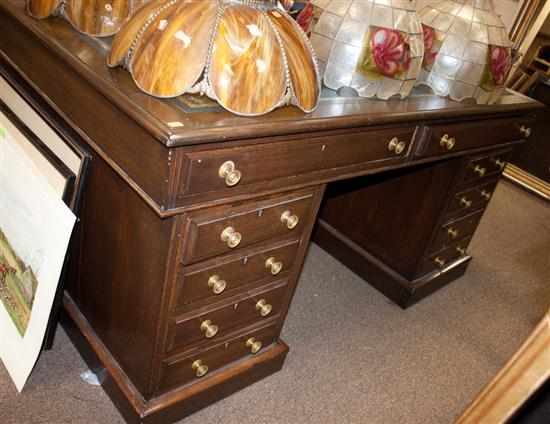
[61,293,288,424]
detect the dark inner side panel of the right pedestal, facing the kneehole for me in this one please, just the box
[320,159,461,278]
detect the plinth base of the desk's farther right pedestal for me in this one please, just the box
[312,219,472,309]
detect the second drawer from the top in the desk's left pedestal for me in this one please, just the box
[173,240,299,310]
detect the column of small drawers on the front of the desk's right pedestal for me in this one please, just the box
[418,150,510,276]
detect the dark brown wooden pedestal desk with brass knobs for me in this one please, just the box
[0,0,539,422]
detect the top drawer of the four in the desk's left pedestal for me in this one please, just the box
[182,193,313,264]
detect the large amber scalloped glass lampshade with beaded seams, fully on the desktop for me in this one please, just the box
[108,0,321,116]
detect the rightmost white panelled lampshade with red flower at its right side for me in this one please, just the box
[418,0,512,104]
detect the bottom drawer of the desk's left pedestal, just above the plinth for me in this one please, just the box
[159,326,277,391]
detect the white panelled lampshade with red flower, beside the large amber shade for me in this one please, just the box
[311,0,424,99]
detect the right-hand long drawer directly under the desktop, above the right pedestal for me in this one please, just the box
[418,119,526,156]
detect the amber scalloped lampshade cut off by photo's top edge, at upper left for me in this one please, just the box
[27,0,147,37]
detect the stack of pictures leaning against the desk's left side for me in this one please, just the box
[0,72,89,390]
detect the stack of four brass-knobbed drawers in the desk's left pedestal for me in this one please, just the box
[158,189,320,392]
